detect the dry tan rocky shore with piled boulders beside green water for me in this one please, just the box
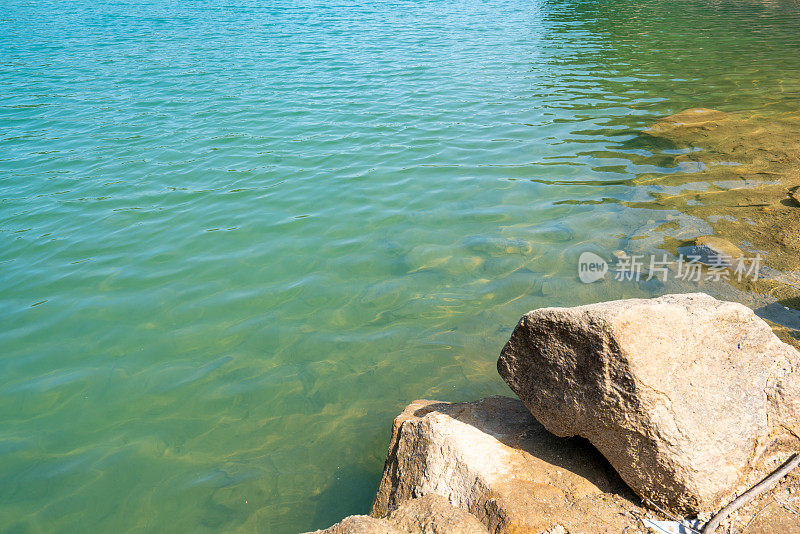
[306,293,800,534]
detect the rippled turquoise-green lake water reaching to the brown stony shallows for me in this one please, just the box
[0,0,800,533]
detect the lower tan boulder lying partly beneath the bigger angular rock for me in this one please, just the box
[372,397,643,534]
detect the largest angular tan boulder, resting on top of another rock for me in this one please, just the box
[497,294,800,513]
